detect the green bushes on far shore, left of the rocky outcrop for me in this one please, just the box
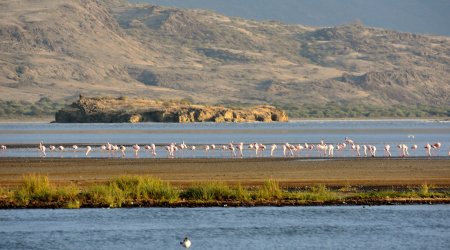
[0,97,67,118]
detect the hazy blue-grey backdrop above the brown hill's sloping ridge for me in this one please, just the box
[130,0,450,36]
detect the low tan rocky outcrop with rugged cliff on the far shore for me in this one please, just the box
[55,96,288,123]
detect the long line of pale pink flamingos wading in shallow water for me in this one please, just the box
[0,137,450,158]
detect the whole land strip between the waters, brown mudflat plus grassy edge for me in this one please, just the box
[0,158,450,209]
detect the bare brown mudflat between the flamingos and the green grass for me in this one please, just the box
[0,158,450,187]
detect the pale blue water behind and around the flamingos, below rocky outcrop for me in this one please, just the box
[0,120,450,157]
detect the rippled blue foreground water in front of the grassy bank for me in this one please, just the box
[0,205,450,250]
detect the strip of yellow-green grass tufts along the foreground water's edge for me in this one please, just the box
[0,175,450,208]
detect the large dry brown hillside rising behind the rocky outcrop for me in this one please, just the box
[0,0,450,115]
